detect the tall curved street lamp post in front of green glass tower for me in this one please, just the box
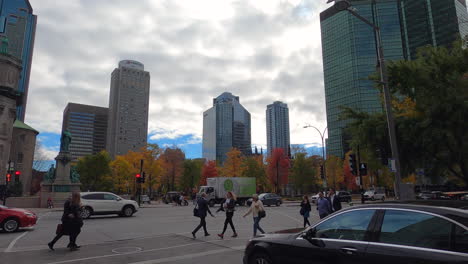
[328,0,401,199]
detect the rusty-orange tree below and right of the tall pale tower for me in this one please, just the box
[161,147,185,190]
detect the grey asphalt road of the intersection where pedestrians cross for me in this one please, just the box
[0,204,346,264]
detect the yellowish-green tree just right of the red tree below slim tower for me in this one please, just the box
[290,153,316,192]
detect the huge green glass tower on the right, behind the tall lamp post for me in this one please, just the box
[320,0,468,157]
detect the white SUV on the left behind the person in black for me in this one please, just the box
[81,192,139,219]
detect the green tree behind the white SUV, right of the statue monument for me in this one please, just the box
[76,151,113,191]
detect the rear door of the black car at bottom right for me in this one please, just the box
[367,209,468,264]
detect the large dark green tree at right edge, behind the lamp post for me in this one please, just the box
[343,41,468,184]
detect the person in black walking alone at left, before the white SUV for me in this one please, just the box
[47,192,83,251]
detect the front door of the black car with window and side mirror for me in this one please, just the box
[288,209,376,264]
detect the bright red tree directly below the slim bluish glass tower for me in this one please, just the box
[267,148,289,193]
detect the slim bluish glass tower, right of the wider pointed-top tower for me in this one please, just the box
[266,101,290,155]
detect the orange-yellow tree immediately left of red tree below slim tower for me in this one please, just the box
[242,155,270,193]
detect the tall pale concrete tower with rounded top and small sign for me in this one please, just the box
[106,60,150,158]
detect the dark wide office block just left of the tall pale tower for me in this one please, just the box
[62,103,109,161]
